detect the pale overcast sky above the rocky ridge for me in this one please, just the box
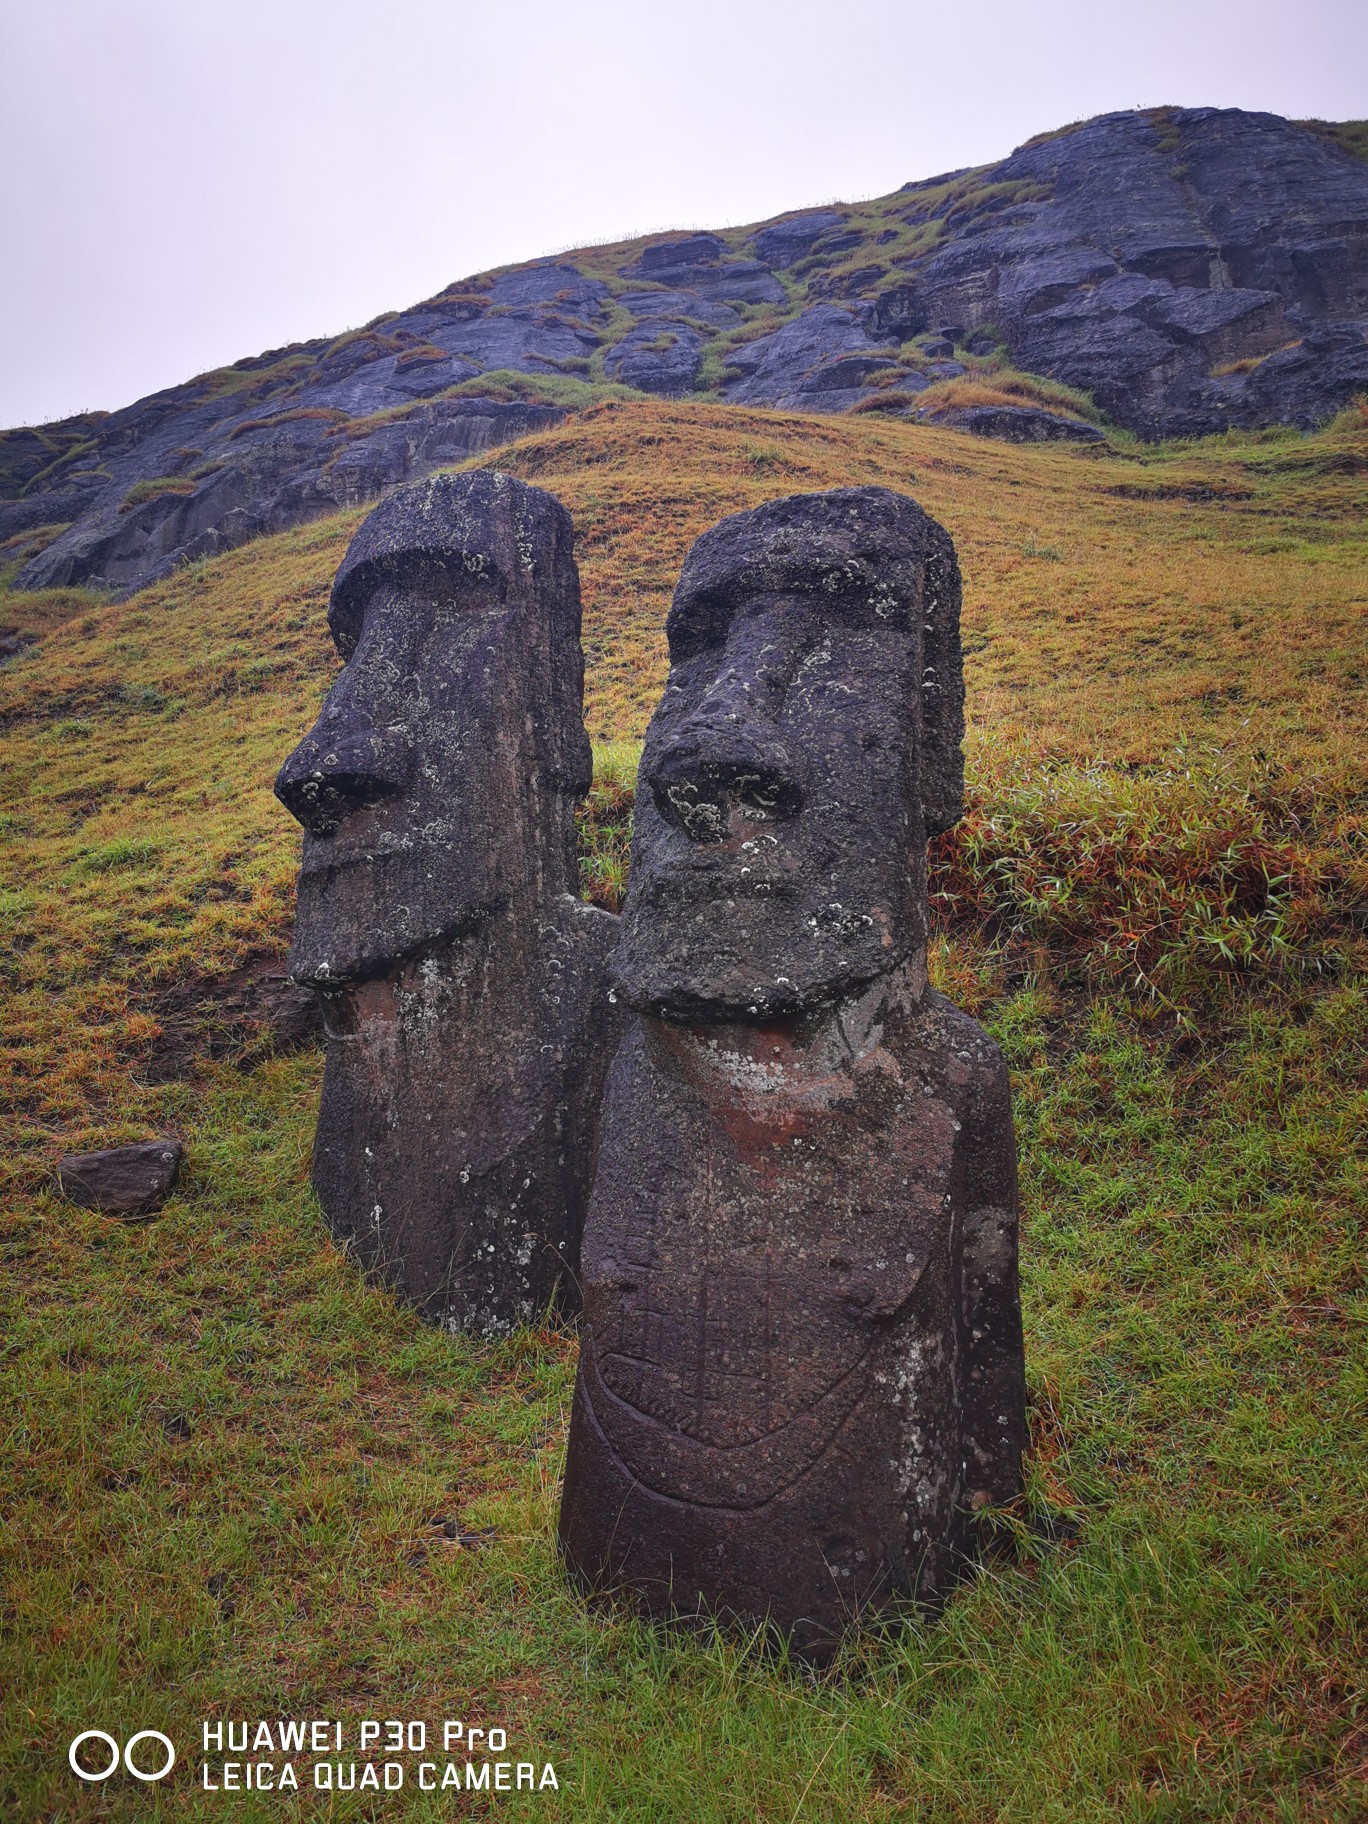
[0,0,1368,425]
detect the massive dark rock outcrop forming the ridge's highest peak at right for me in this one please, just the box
[916,108,1368,436]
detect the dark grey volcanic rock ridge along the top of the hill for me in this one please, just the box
[0,108,1368,591]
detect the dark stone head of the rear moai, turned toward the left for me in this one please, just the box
[275,471,593,987]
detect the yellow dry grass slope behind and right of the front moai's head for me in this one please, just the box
[500,405,1368,764]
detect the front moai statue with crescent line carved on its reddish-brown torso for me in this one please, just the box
[560,487,1025,1658]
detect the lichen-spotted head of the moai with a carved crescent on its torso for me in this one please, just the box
[615,487,963,1021]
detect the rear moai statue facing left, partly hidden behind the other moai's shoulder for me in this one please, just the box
[275,471,620,1333]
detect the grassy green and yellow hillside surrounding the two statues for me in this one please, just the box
[0,401,1368,1824]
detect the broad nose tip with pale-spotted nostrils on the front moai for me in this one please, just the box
[649,730,803,843]
